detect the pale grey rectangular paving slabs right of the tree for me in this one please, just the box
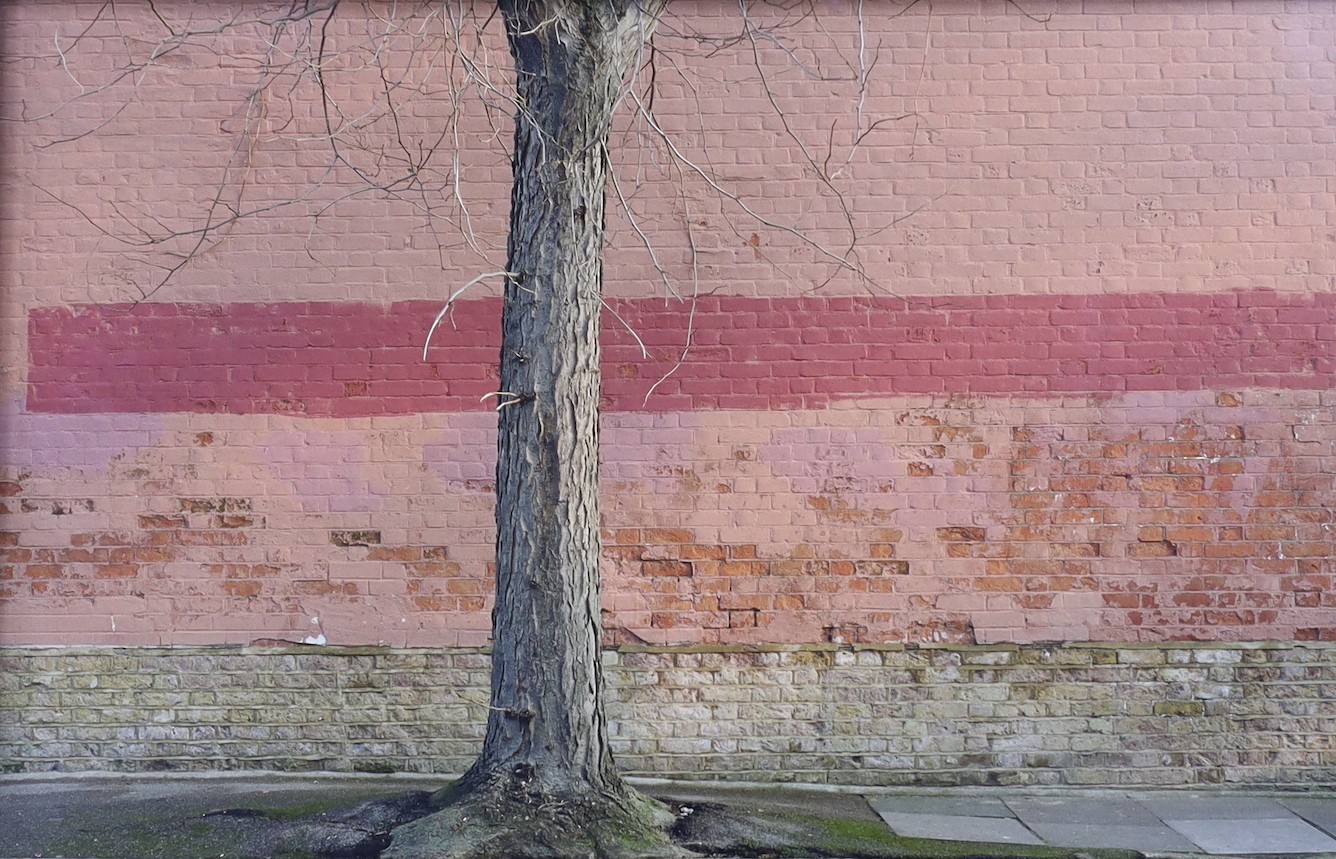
[867,790,1336,856]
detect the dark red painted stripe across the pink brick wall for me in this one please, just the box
[28,291,1336,417]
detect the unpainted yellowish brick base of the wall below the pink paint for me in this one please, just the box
[0,644,1336,788]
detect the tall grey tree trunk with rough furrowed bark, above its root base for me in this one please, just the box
[464,0,656,798]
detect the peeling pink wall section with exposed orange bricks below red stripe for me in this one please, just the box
[0,391,1336,645]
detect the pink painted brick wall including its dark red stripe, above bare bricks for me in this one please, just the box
[0,0,1336,645]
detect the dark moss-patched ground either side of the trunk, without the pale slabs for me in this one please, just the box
[0,776,1142,859]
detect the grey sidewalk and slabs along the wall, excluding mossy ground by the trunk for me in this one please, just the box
[0,772,1336,859]
